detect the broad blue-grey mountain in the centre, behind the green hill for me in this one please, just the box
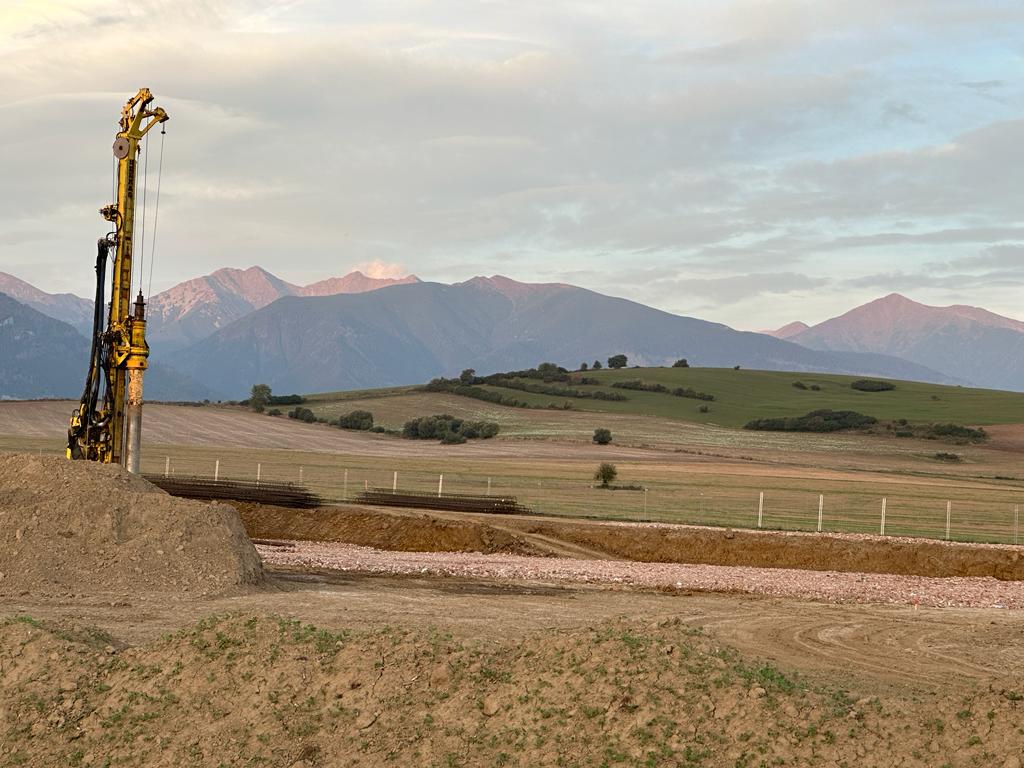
[168,276,948,396]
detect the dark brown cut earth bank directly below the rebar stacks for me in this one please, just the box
[232,502,549,556]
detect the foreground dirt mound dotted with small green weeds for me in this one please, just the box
[0,615,1024,768]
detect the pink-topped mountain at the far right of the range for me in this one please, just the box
[791,294,1024,391]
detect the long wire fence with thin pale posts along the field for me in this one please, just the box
[142,455,1024,545]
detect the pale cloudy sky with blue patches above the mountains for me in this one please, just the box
[0,0,1024,329]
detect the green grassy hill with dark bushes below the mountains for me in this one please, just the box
[310,368,1024,427]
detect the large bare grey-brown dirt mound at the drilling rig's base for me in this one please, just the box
[0,454,262,597]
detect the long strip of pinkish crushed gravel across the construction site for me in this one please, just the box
[257,542,1024,609]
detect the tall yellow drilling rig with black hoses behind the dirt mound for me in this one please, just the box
[68,88,168,473]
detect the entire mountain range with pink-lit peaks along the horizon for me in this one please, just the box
[0,266,1024,399]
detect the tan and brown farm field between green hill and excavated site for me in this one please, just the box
[0,393,1024,544]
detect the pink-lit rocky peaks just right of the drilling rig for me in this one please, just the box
[147,266,418,351]
